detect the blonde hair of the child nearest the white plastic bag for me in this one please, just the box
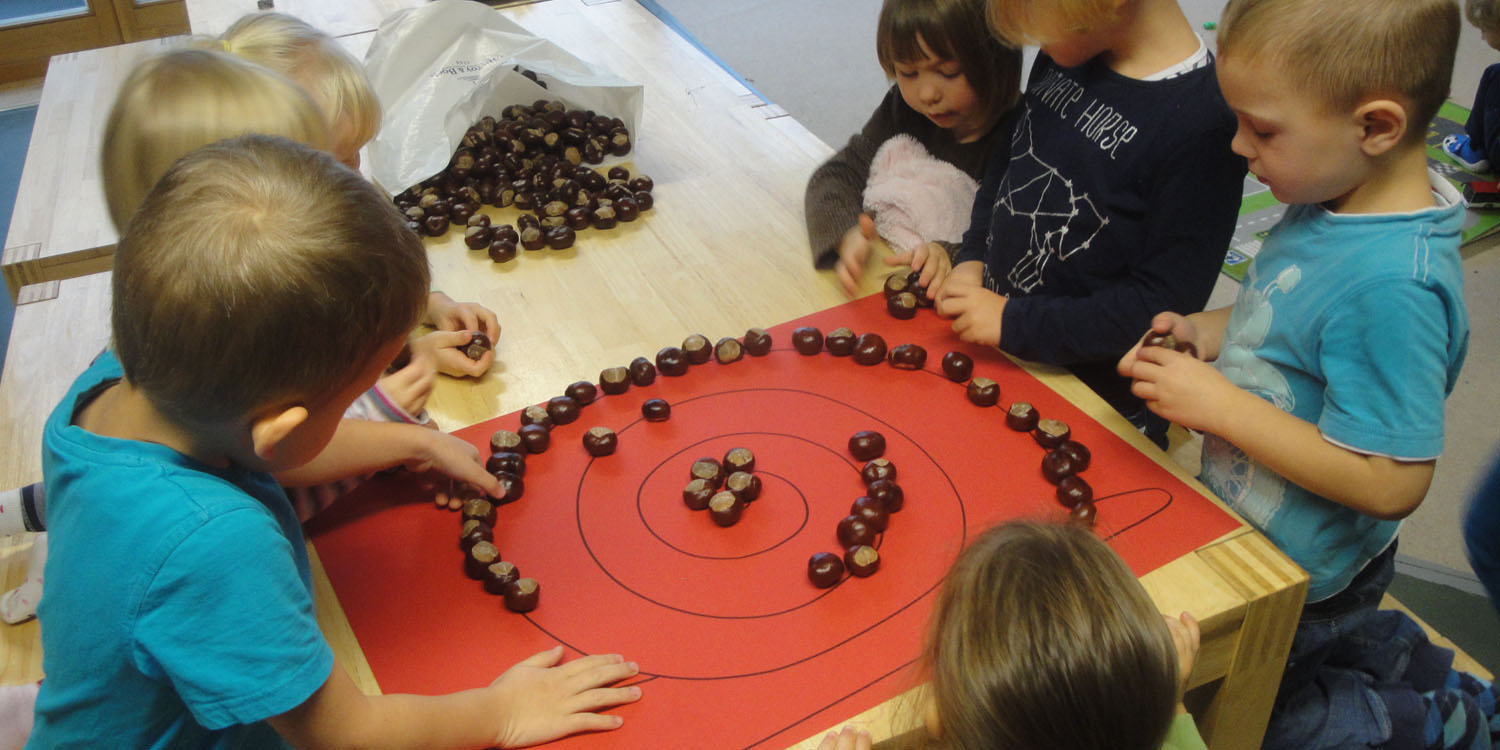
[219,12,381,165]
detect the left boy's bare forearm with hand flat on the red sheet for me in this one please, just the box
[270,647,641,749]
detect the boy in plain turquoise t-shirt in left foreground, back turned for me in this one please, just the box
[30,137,639,747]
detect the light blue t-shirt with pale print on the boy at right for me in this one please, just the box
[1202,176,1469,602]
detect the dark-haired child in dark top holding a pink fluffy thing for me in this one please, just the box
[806,0,1020,294]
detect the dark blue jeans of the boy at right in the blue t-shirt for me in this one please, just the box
[1262,543,1454,750]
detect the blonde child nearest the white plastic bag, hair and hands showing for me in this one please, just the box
[217,12,500,384]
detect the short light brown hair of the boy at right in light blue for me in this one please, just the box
[1218,0,1461,144]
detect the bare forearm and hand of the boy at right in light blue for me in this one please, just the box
[1130,347,1436,521]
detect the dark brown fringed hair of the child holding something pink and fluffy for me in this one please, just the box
[875,0,1022,122]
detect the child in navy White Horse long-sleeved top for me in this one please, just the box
[930,0,1245,447]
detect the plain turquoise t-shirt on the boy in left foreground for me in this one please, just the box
[27,353,333,749]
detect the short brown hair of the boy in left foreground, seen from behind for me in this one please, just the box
[111,135,429,428]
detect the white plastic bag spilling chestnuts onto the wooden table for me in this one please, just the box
[365,0,645,195]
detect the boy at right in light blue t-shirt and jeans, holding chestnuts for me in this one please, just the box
[1119,0,1496,750]
